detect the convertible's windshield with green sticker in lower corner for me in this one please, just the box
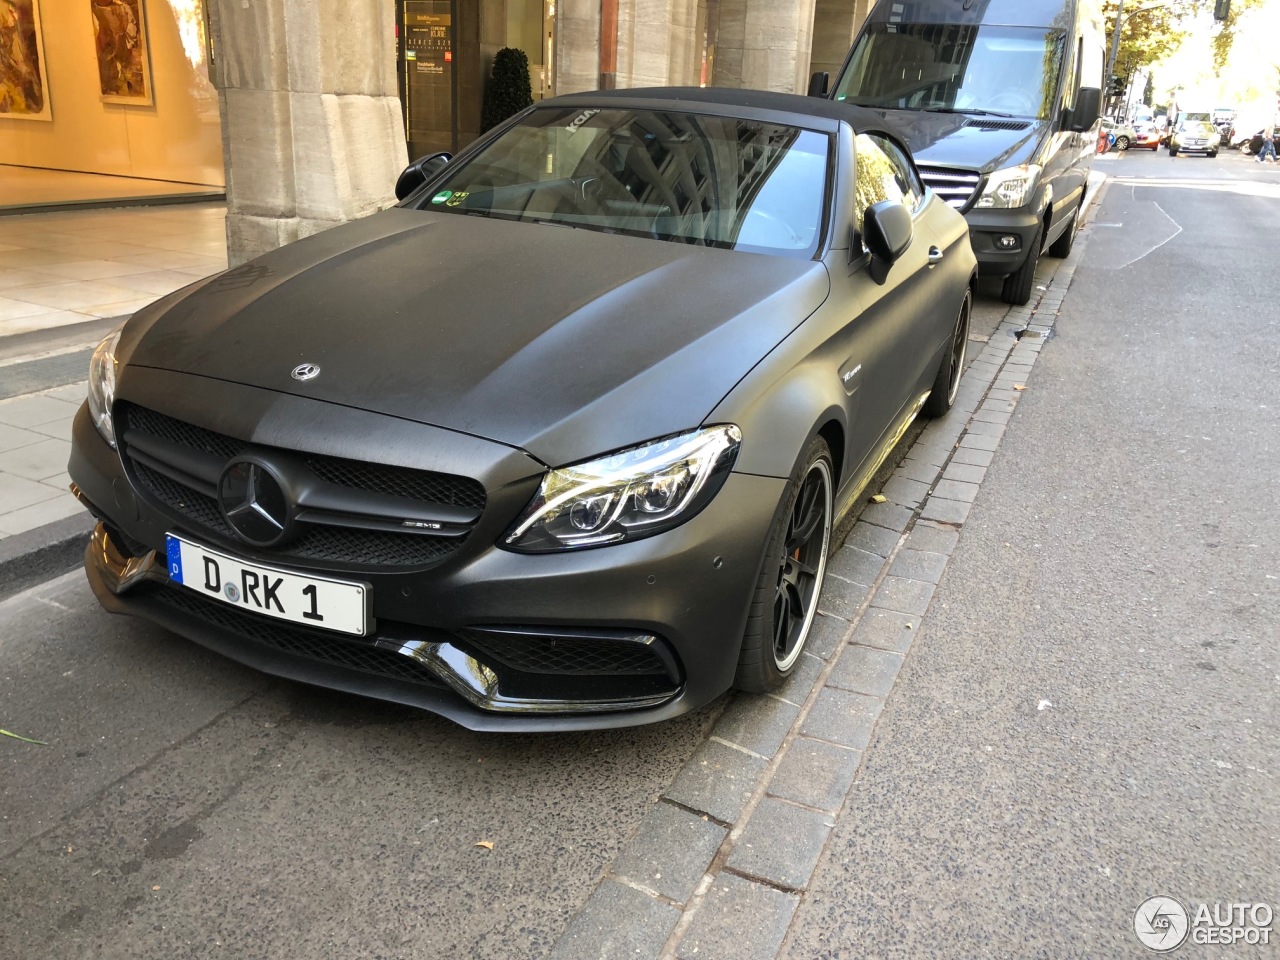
[417,108,831,259]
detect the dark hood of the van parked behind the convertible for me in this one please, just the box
[884,110,1048,173]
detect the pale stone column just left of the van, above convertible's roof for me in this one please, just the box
[712,0,814,93]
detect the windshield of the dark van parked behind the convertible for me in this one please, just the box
[836,23,1062,120]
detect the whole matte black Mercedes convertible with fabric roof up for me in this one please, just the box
[69,90,975,730]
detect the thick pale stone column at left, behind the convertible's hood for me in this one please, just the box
[210,0,407,265]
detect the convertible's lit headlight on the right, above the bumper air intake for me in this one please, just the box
[504,425,742,553]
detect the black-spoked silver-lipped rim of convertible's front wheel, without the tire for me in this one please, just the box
[773,460,832,673]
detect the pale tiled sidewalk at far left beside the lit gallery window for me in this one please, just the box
[0,202,227,596]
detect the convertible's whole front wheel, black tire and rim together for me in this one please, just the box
[733,436,835,694]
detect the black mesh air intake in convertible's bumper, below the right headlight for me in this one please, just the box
[466,630,668,677]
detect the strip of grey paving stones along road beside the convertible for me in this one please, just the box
[550,212,1105,960]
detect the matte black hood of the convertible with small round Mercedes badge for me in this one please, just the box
[119,209,831,465]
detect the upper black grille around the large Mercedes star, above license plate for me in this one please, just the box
[115,402,485,570]
